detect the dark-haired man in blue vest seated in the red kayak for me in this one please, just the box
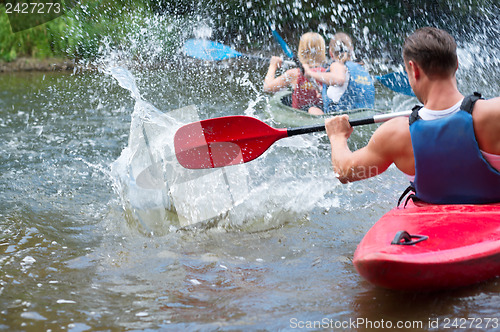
[325,27,500,204]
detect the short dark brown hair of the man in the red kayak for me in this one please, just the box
[403,27,458,76]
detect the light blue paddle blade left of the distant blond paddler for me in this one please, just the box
[183,39,295,65]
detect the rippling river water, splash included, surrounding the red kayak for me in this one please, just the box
[0,18,500,331]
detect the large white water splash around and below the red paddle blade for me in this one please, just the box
[106,68,340,234]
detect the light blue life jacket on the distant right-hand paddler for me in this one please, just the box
[322,61,375,113]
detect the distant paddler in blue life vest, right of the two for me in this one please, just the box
[304,32,375,115]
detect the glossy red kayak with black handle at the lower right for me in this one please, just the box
[353,201,500,290]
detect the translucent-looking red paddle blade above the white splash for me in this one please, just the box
[174,115,288,169]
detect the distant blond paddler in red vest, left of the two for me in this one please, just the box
[264,32,326,111]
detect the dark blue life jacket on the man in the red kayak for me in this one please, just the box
[410,93,500,204]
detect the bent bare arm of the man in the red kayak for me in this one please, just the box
[325,115,415,183]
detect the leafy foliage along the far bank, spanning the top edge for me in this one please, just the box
[0,0,500,61]
